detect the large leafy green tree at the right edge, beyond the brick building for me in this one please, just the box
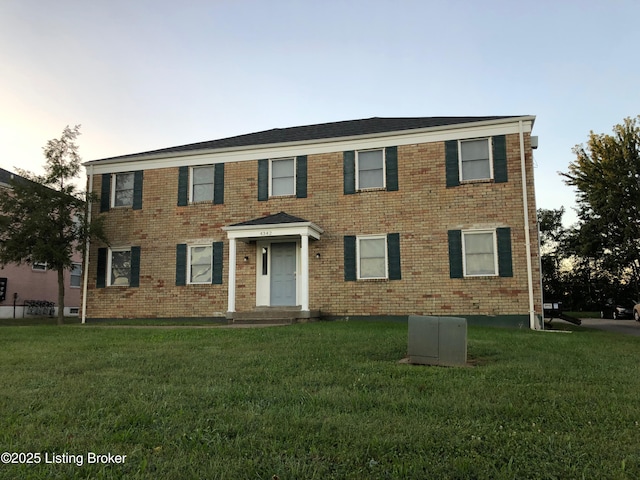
[561,116,640,302]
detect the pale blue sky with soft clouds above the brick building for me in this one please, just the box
[0,0,640,223]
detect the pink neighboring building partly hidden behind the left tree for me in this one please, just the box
[0,168,82,318]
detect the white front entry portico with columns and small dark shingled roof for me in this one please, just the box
[223,212,323,318]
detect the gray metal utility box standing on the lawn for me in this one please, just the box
[408,315,467,366]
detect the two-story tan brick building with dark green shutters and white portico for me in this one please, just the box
[85,116,542,328]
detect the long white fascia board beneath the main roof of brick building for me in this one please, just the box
[83,116,535,174]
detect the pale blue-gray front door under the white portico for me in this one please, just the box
[270,242,297,306]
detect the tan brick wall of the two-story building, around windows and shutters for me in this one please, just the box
[87,134,541,318]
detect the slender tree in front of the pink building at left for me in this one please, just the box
[0,125,105,325]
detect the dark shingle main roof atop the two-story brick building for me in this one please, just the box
[89,115,514,163]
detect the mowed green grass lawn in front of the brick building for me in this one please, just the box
[0,322,640,479]
